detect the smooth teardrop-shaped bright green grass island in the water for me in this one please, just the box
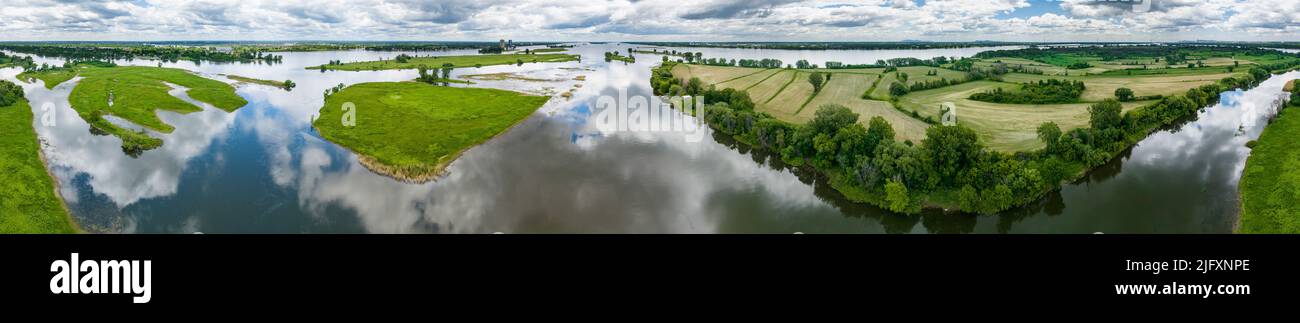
[313,82,549,182]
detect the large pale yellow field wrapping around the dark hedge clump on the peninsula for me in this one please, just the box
[900,81,1152,152]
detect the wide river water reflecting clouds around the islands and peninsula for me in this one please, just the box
[0,44,1300,233]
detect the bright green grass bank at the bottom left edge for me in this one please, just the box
[0,100,77,233]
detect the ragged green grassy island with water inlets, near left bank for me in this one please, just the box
[18,65,248,155]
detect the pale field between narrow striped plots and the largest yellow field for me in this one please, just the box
[794,74,930,143]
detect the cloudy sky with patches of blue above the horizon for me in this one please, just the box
[0,0,1300,42]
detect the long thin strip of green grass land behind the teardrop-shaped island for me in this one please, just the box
[307,53,581,70]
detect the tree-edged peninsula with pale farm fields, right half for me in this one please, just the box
[651,46,1284,214]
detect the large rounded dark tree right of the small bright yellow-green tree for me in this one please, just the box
[920,125,984,185]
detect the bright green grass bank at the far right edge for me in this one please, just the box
[1238,107,1300,233]
